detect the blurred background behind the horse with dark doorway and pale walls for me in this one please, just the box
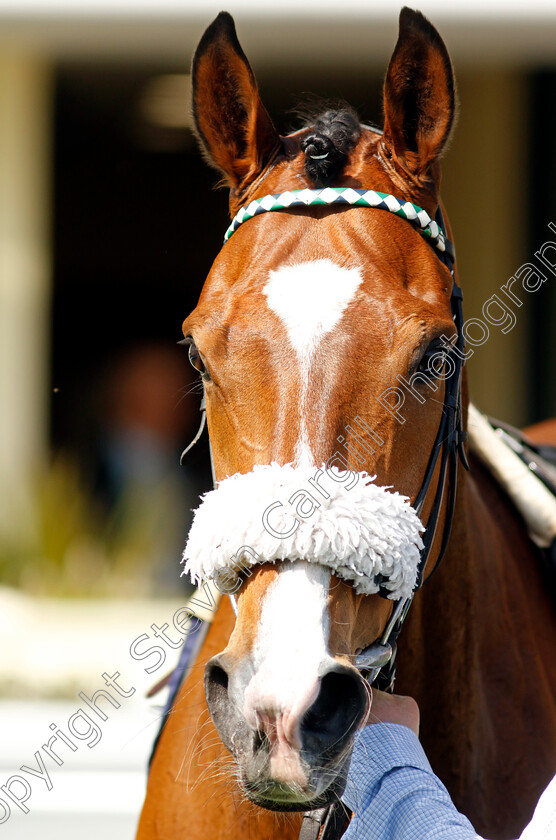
[0,0,556,840]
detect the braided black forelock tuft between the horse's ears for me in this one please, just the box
[301,107,361,187]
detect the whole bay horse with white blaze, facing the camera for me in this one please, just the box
[137,8,556,840]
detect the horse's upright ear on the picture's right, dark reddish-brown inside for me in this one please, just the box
[384,7,455,178]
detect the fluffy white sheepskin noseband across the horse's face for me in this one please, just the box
[183,463,424,599]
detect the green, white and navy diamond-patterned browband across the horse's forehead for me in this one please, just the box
[224,187,455,260]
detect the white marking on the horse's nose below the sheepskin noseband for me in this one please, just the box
[244,560,333,746]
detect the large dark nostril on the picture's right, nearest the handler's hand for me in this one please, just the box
[301,665,367,759]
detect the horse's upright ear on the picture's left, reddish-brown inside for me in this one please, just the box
[191,12,279,191]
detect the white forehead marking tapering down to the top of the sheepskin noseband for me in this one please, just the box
[263,260,363,466]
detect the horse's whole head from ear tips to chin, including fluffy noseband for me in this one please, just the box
[183,9,459,810]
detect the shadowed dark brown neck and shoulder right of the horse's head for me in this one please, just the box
[396,450,556,837]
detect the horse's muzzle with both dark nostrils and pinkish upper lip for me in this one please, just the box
[205,652,368,811]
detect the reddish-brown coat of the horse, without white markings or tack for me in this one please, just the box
[137,9,556,840]
